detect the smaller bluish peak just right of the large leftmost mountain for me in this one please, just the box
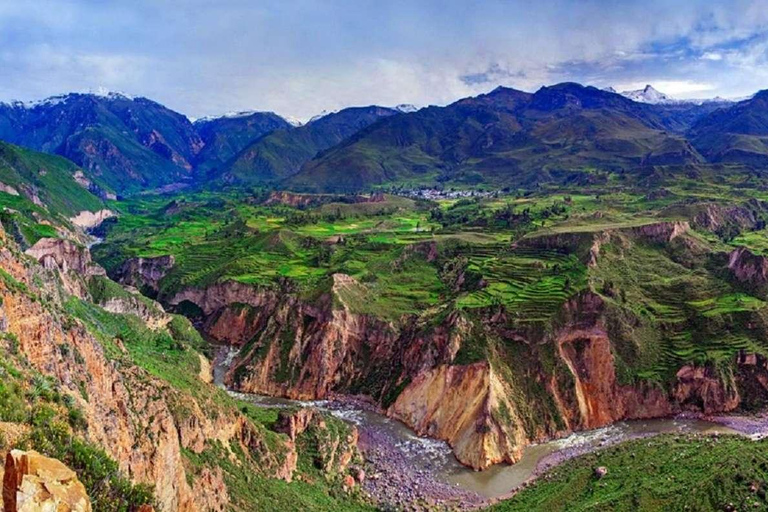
[194,112,293,173]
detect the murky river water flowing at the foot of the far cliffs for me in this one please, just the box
[214,349,738,498]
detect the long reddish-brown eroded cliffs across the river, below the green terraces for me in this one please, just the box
[159,228,766,469]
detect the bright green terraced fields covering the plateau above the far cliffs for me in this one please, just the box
[95,180,768,383]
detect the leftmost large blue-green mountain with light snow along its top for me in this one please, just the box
[0,93,203,193]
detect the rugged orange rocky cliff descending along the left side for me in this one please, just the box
[0,223,356,512]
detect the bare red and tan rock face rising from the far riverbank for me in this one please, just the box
[189,278,768,468]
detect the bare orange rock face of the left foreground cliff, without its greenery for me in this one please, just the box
[0,227,312,512]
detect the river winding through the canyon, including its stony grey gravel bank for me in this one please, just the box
[214,349,752,508]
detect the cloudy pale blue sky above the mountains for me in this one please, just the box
[0,0,768,120]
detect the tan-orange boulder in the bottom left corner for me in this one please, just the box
[3,450,91,512]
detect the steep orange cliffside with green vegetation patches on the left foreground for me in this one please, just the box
[0,225,368,512]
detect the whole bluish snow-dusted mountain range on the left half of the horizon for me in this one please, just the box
[0,93,402,197]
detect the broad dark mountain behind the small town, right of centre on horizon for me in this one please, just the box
[286,83,703,191]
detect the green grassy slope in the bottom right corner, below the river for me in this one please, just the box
[492,435,768,512]
